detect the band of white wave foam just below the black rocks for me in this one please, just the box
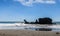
[0,23,60,28]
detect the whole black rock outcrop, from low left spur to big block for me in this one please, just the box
[24,17,53,24]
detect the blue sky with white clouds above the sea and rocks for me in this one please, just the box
[0,0,60,21]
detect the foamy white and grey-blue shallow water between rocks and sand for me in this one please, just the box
[0,23,60,31]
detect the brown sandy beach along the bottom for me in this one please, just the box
[0,30,60,36]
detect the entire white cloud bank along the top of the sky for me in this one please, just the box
[14,0,56,6]
